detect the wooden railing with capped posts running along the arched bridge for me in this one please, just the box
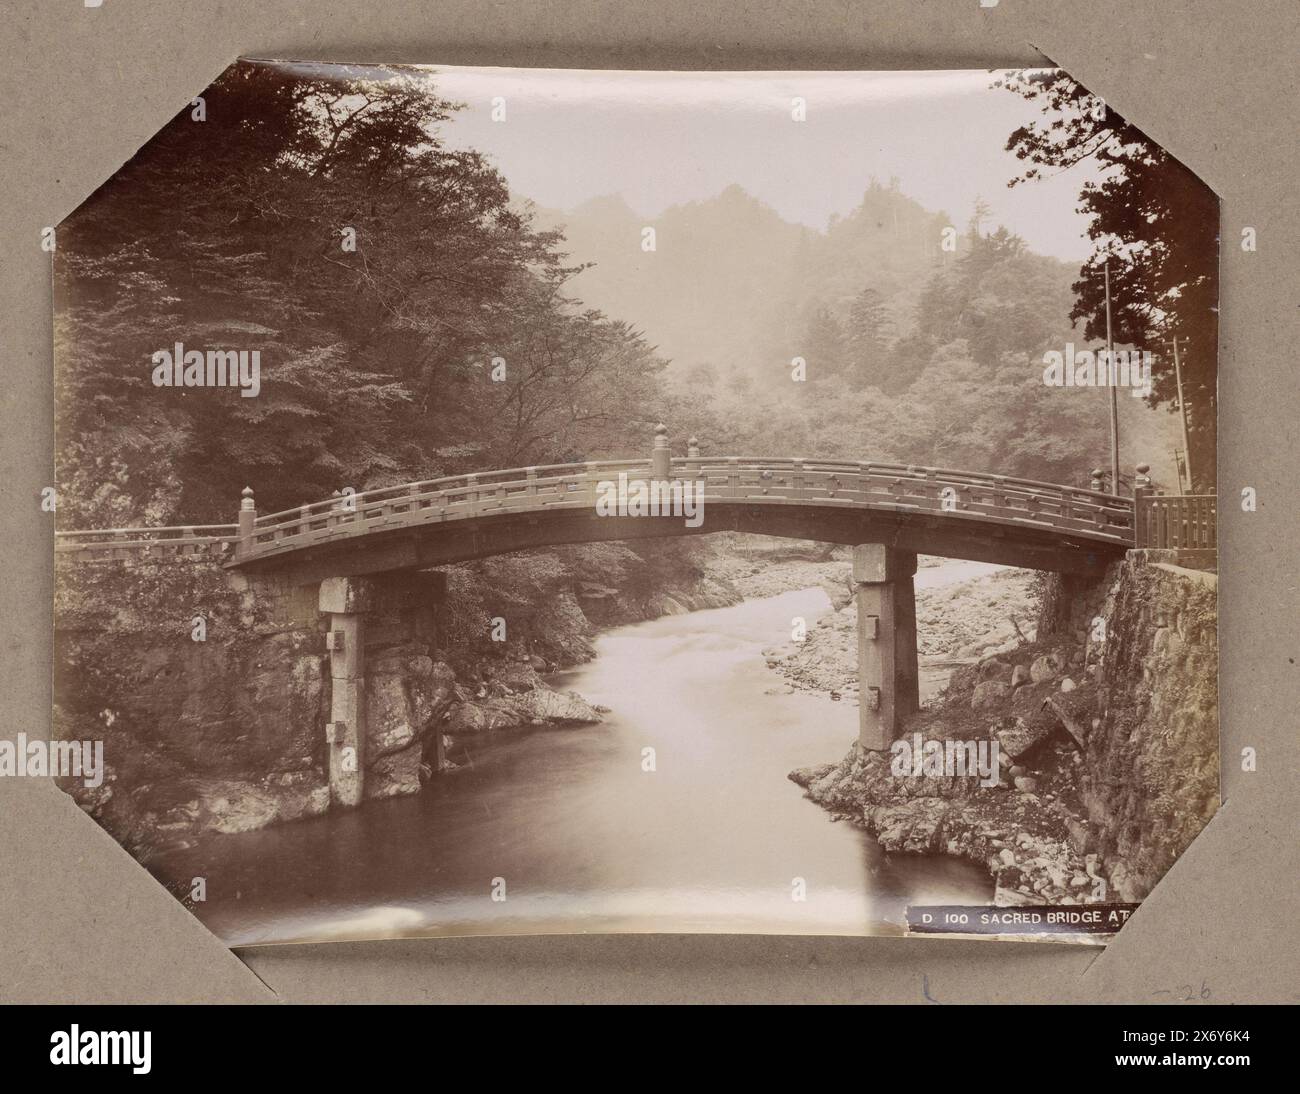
[56,426,1190,561]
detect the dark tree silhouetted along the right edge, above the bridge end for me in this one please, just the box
[995,70,1219,491]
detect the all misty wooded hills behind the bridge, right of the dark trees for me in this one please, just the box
[538,179,1175,486]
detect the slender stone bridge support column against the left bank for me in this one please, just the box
[319,577,371,806]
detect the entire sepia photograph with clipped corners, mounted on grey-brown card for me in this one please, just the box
[48,58,1221,947]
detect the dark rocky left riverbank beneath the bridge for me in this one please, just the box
[53,541,742,860]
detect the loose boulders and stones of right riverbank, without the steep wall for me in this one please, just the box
[767,560,1106,906]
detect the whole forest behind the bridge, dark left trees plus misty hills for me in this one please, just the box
[55,62,1213,528]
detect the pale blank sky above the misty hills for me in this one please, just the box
[418,68,1097,261]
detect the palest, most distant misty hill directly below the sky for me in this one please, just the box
[527,181,967,384]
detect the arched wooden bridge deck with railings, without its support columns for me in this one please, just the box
[48,427,1216,582]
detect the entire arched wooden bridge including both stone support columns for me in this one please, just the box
[56,426,1216,774]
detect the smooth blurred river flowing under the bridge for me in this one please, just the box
[151,563,993,946]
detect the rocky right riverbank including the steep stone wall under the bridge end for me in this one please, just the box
[771,552,1218,906]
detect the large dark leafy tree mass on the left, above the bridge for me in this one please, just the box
[55,62,662,526]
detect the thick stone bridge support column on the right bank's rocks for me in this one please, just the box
[853,543,920,751]
